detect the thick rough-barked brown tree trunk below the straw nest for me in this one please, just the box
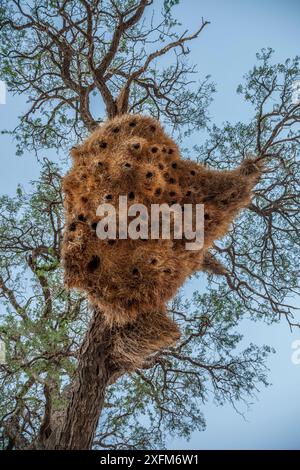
[43,309,117,450]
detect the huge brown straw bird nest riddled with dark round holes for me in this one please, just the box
[63,115,260,363]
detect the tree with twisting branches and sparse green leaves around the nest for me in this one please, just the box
[0,0,300,449]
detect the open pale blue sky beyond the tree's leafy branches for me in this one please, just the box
[0,0,300,449]
